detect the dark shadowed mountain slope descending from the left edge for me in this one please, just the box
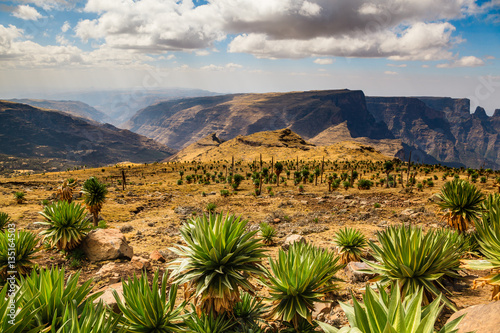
[0,100,175,170]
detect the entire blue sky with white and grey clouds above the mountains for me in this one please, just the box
[0,0,500,114]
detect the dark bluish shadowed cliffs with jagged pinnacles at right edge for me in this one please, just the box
[366,97,500,168]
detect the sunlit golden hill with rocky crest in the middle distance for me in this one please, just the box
[165,128,392,162]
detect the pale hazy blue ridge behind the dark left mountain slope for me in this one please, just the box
[9,98,111,123]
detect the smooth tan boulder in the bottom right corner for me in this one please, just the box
[448,301,500,333]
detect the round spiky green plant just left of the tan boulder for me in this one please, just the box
[37,201,92,251]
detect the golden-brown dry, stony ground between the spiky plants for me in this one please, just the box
[0,163,498,324]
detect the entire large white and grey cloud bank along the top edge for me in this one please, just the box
[69,0,472,60]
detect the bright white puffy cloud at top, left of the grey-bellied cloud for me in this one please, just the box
[75,0,225,53]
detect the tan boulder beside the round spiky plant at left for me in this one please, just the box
[81,229,134,261]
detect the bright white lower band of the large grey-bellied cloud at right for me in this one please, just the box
[228,22,455,60]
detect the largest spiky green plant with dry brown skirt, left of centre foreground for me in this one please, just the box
[170,214,265,314]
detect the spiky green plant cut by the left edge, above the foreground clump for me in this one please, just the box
[0,230,39,281]
